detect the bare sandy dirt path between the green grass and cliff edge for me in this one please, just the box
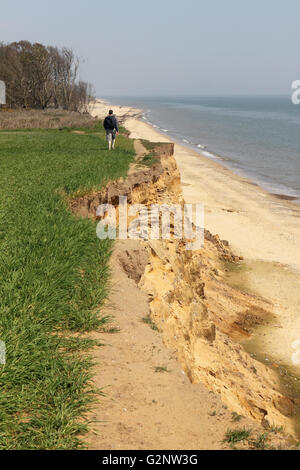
[87,240,257,450]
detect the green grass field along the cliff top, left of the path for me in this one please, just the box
[0,126,134,449]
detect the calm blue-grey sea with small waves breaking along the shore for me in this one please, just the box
[107,96,300,198]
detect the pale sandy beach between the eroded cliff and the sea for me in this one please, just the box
[91,101,300,430]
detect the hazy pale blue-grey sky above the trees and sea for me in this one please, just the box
[0,0,300,96]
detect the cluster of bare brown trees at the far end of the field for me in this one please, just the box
[0,41,93,112]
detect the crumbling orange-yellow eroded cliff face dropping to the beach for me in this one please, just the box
[71,140,293,433]
